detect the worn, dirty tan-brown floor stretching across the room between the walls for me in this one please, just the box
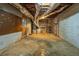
[0,34,79,56]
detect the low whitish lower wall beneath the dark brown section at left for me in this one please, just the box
[0,32,21,49]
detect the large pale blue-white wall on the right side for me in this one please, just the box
[59,12,79,48]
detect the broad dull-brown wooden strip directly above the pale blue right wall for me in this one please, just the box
[54,4,79,21]
